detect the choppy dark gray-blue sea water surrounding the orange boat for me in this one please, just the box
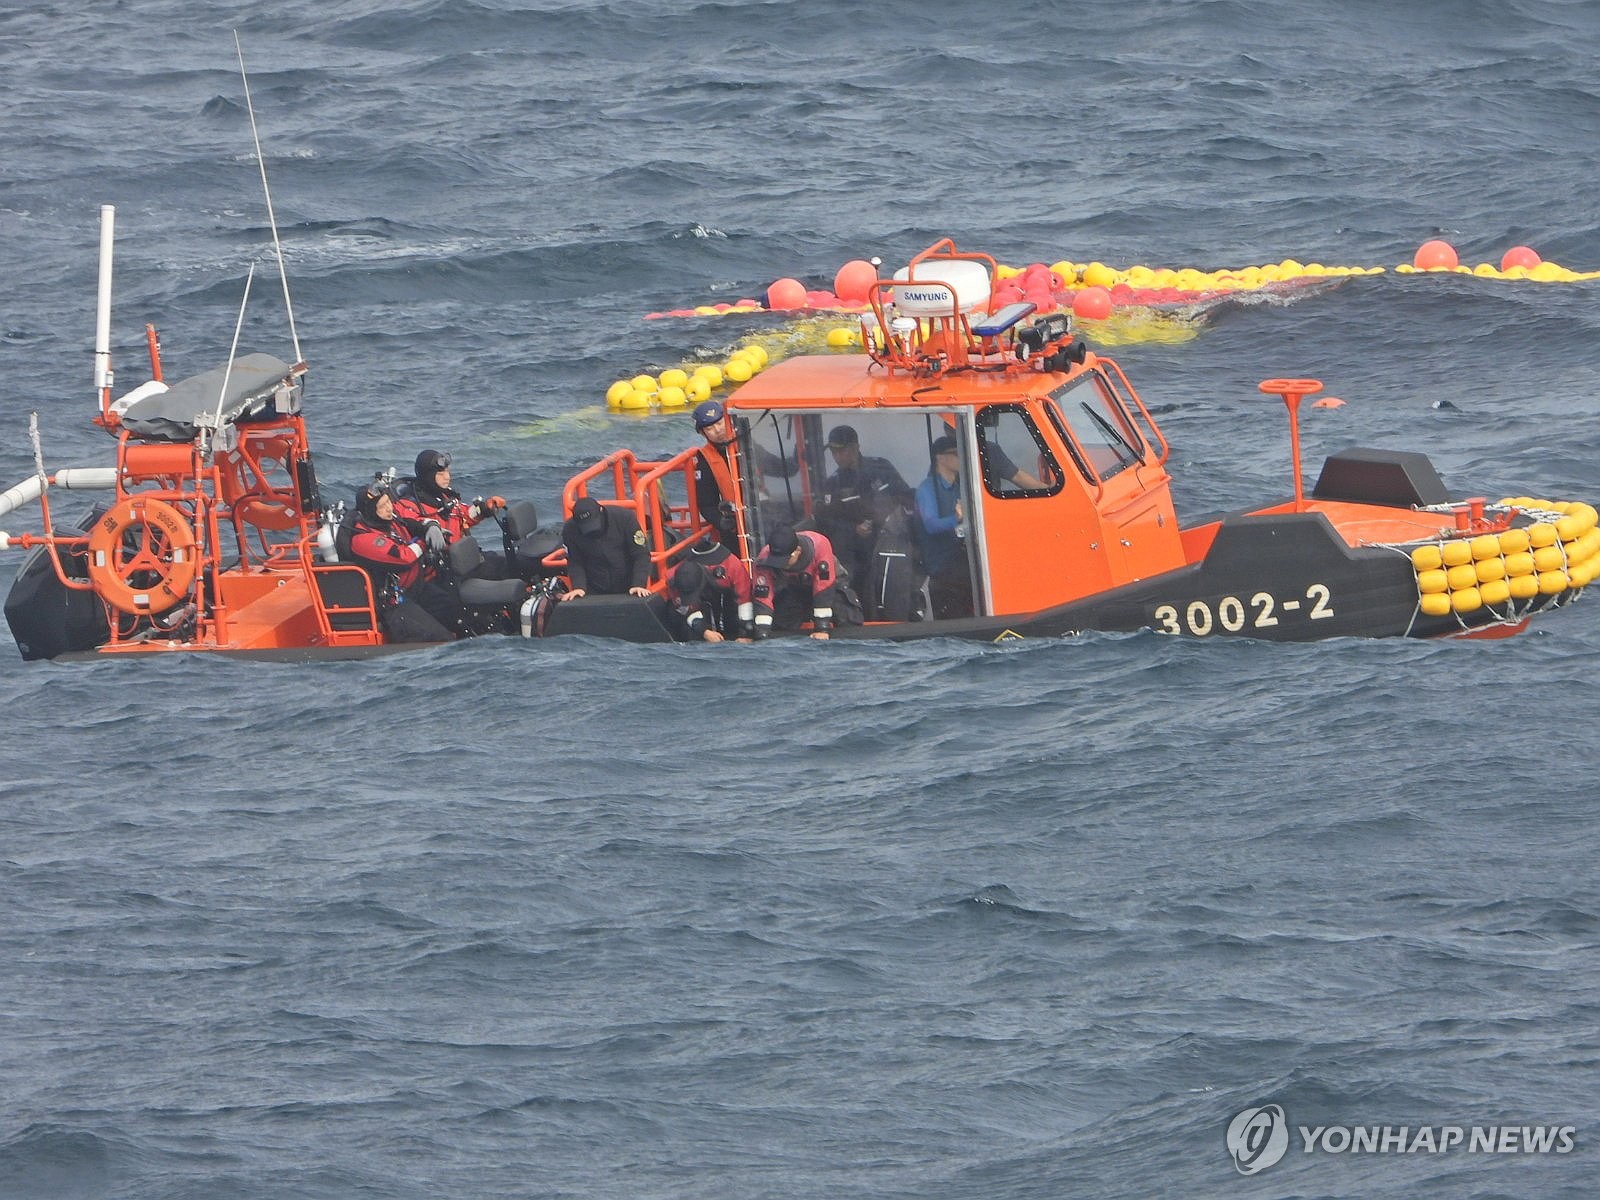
[0,0,1600,1200]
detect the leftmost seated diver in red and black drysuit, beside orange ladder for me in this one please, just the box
[350,482,456,642]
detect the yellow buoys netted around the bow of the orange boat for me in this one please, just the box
[1410,496,1600,616]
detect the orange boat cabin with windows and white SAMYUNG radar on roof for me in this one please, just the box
[566,242,1186,622]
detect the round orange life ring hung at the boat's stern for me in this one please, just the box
[90,496,200,616]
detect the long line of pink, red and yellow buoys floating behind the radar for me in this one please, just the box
[648,238,1600,320]
